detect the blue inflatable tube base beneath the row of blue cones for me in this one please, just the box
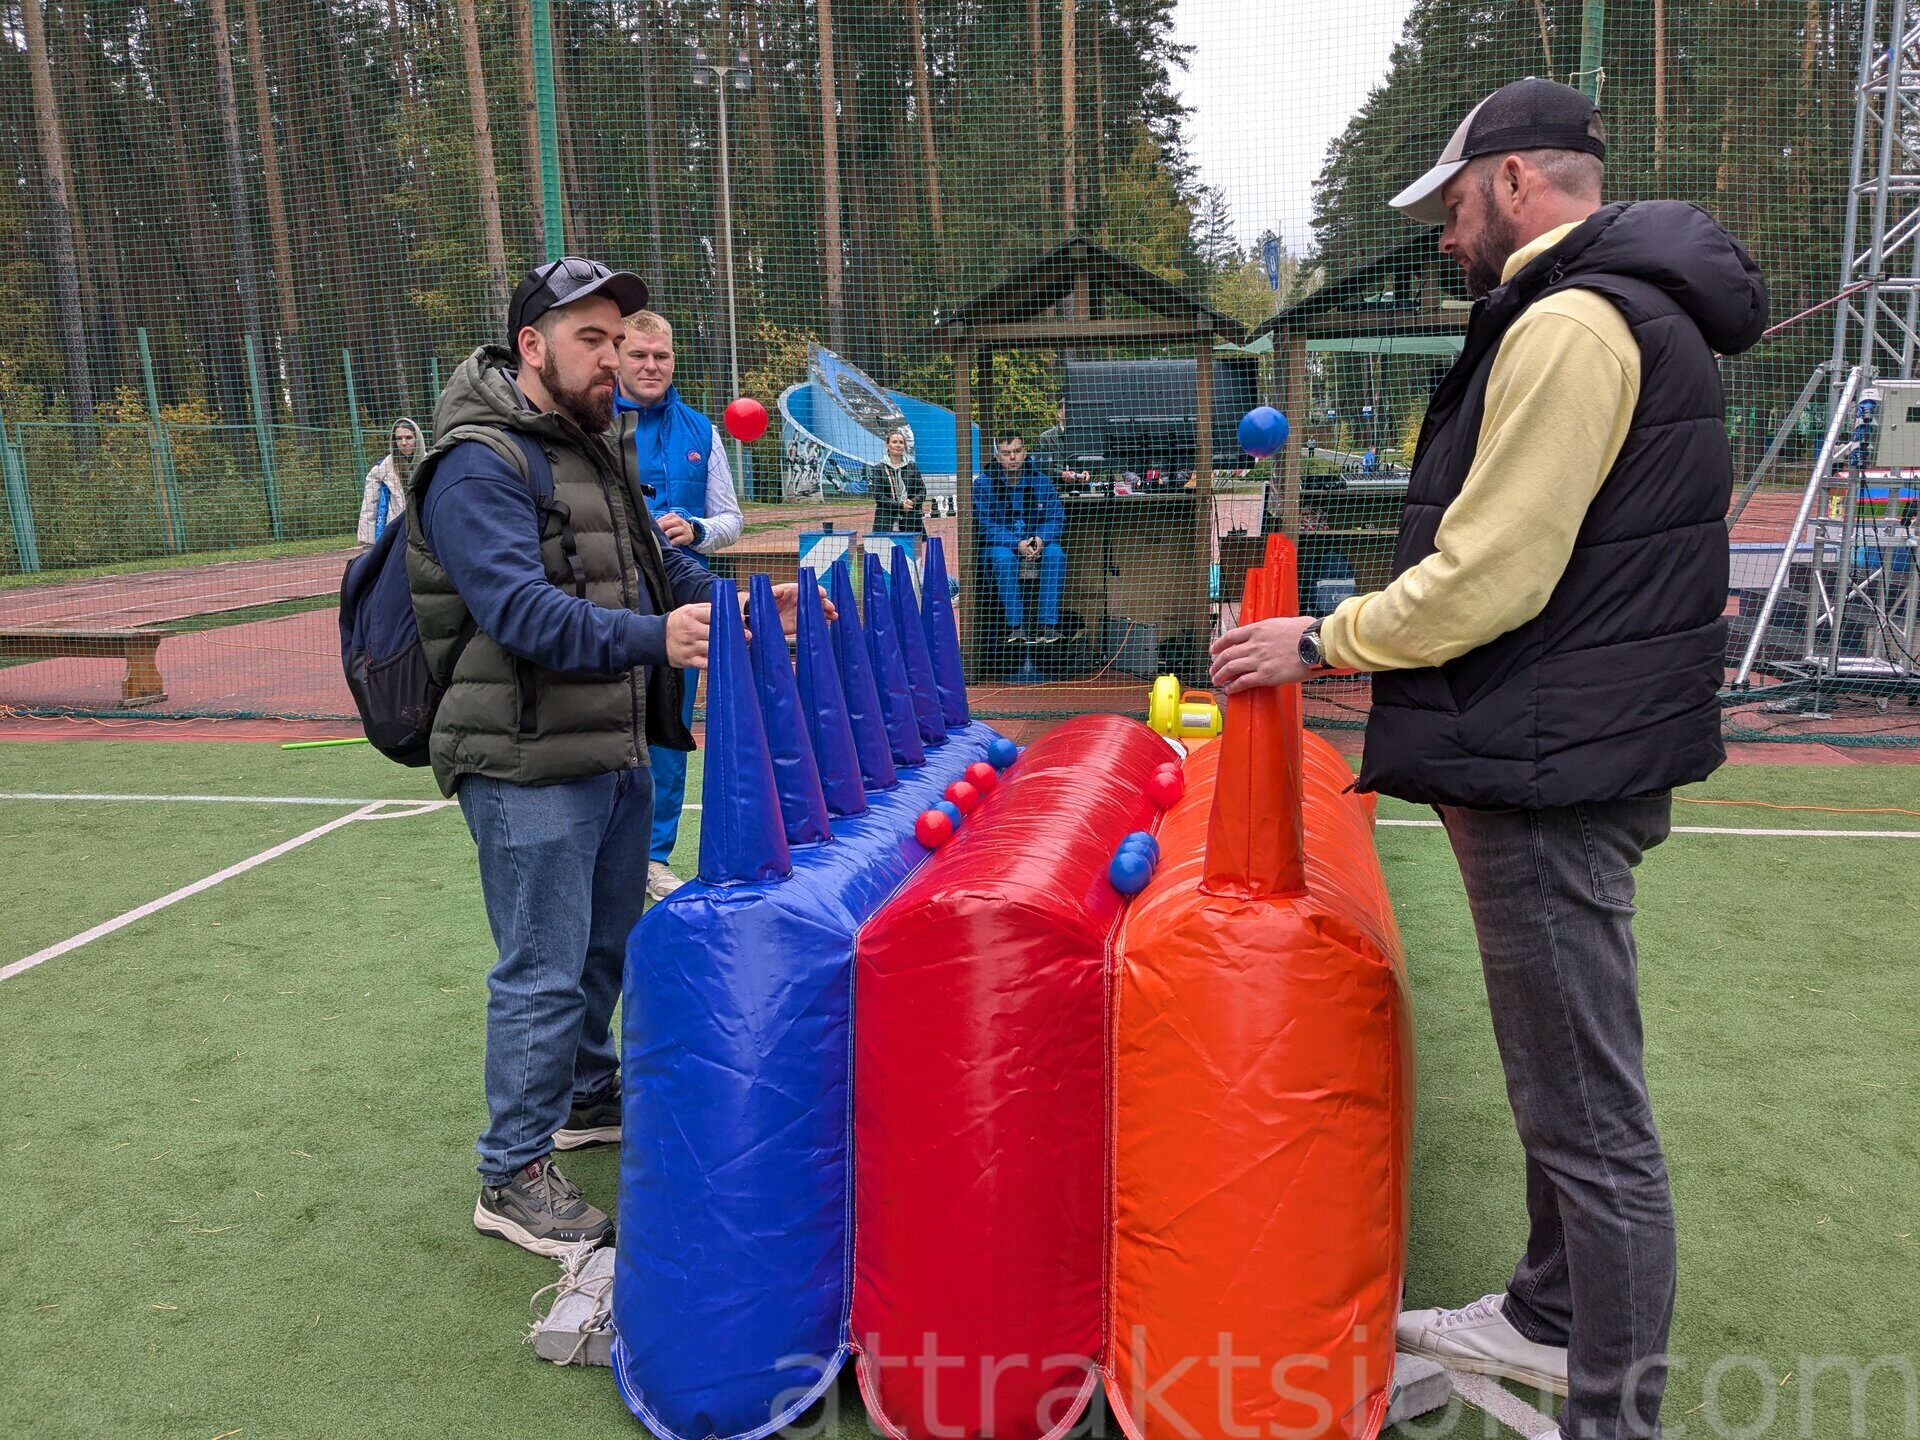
[612,724,996,1440]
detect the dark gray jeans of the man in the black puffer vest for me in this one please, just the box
[1440,793,1676,1440]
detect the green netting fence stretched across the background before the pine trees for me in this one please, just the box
[0,0,1920,743]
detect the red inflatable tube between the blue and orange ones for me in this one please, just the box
[852,716,1169,1440]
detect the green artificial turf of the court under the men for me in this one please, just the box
[0,743,1920,1440]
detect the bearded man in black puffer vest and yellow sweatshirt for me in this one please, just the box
[1213,79,1766,1440]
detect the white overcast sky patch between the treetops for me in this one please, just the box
[1173,0,1411,253]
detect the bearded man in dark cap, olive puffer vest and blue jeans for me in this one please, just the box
[407,255,821,1256]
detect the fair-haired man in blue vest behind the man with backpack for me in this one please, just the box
[614,309,743,900]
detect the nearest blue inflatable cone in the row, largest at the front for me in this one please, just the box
[701,580,793,885]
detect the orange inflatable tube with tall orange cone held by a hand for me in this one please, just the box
[1104,540,1413,1440]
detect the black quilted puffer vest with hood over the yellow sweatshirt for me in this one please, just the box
[1359,202,1766,808]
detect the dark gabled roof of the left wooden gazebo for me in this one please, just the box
[933,236,1246,344]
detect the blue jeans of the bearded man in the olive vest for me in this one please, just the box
[459,768,653,1185]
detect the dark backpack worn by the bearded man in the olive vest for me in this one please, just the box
[340,426,586,766]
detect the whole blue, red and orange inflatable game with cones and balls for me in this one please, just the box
[612,540,1413,1440]
